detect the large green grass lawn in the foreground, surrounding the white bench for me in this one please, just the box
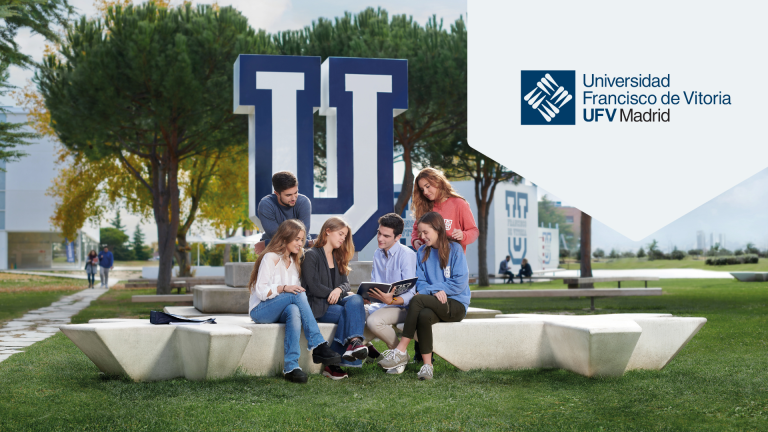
[0,280,768,431]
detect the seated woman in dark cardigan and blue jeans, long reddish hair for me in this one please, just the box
[301,216,368,380]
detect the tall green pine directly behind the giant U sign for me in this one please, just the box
[274,8,467,213]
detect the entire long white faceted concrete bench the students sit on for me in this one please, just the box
[61,314,706,381]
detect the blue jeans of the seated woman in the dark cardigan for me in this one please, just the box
[317,295,365,367]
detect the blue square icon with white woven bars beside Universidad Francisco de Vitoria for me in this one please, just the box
[520,71,576,125]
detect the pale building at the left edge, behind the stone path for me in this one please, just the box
[0,108,99,269]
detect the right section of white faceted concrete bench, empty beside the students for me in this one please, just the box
[400,314,706,377]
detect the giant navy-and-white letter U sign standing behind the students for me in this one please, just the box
[233,55,408,250]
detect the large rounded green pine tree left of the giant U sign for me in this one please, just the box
[35,2,272,294]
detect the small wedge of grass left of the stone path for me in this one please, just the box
[0,273,88,327]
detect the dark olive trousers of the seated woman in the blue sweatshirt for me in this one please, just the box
[403,294,467,354]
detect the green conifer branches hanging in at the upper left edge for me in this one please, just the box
[0,0,72,162]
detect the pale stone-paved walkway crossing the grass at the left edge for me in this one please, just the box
[0,272,117,362]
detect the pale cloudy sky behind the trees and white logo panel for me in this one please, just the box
[6,0,768,251]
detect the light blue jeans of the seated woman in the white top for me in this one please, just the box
[251,293,325,373]
